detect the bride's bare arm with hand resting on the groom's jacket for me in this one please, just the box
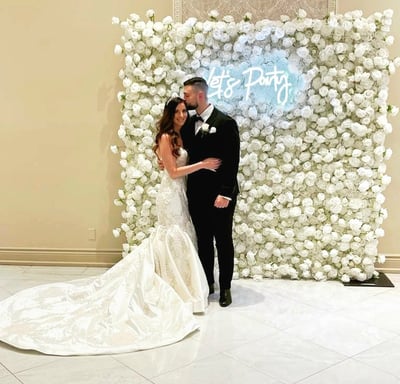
[159,134,221,179]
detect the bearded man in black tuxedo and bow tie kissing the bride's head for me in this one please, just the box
[181,77,240,307]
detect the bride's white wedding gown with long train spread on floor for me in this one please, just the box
[0,150,208,355]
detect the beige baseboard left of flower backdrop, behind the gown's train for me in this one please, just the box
[0,248,122,267]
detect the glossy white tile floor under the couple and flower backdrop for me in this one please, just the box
[0,265,400,384]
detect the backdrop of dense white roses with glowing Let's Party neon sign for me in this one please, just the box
[111,10,400,282]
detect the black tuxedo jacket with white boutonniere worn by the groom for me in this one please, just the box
[181,107,240,204]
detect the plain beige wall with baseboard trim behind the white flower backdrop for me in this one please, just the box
[0,0,400,264]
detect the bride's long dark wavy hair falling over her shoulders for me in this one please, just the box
[153,97,186,157]
